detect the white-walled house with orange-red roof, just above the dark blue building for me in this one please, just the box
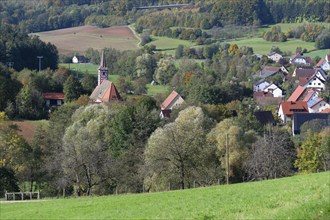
[278,101,308,124]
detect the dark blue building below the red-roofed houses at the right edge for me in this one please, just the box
[292,113,330,135]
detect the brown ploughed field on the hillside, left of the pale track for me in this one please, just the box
[34,26,139,55]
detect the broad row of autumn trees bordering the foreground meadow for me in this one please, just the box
[0,99,330,196]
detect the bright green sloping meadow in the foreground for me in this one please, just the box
[0,172,330,220]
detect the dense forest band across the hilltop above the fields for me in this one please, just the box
[0,0,329,34]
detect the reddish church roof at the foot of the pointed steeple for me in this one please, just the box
[90,80,121,102]
